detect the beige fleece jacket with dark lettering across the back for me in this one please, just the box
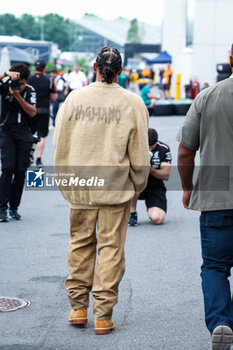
[54,82,149,208]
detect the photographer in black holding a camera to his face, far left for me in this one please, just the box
[0,64,36,222]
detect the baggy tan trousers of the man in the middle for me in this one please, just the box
[65,202,130,320]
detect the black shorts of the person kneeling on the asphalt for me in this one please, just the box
[138,185,167,213]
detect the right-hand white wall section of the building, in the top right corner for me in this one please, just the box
[193,0,233,85]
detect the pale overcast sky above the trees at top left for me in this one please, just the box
[0,0,164,25]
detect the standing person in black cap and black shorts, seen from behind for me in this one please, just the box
[28,59,57,167]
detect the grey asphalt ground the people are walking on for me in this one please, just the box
[0,117,214,350]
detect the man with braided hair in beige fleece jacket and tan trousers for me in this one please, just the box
[54,47,149,334]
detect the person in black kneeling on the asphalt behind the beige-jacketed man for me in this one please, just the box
[128,129,172,226]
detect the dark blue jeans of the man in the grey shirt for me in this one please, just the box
[200,210,233,333]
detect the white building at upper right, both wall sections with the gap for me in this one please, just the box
[162,0,233,97]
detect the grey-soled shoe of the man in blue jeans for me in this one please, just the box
[212,326,233,350]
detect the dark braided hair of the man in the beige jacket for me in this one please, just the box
[96,46,122,84]
